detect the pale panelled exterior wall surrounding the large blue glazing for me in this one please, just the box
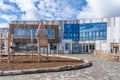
[9,17,120,54]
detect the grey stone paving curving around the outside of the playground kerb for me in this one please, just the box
[0,54,120,80]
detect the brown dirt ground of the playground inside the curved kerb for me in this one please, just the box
[0,55,83,71]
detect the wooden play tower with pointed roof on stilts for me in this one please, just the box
[36,23,48,62]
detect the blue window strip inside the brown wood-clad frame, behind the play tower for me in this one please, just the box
[14,28,55,39]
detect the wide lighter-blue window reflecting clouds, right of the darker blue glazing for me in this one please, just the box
[79,22,107,40]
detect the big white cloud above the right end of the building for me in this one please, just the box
[77,0,120,19]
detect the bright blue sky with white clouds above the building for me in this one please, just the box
[0,0,120,27]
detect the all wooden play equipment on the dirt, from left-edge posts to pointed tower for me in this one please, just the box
[0,23,48,63]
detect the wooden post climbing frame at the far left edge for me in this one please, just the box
[0,32,14,63]
